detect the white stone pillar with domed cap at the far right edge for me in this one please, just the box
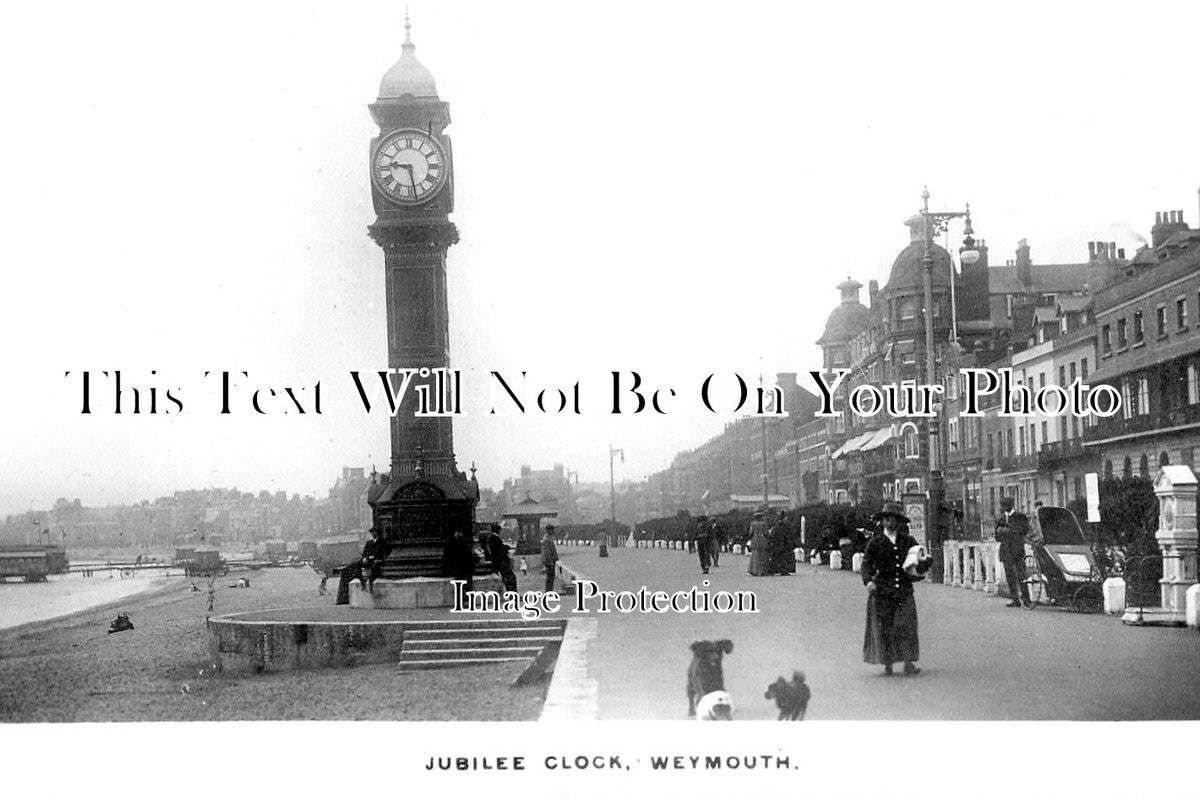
[1122,464,1200,625]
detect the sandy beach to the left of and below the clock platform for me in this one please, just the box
[0,569,546,723]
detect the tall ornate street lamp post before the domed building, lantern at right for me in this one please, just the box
[920,186,979,583]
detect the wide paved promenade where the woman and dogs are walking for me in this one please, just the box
[560,547,1200,720]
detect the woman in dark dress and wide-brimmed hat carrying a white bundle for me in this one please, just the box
[863,503,932,675]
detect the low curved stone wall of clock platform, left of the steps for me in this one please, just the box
[208,612,406,673]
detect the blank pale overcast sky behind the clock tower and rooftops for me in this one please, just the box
[0,0,1200,513]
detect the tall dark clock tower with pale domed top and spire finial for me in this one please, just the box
[367,14,479,578]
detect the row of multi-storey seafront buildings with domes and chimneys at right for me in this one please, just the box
[648,200,1200,536]
